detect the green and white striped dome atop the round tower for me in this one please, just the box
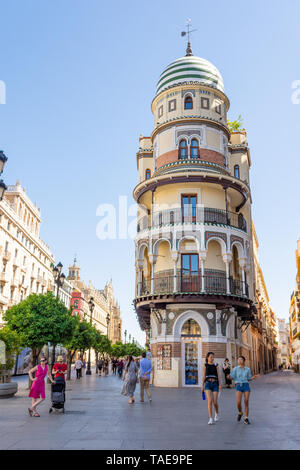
[156,55,224,95]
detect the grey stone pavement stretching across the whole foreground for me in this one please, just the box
[0,371,300,450]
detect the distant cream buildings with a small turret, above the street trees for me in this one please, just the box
[67,259,122,343]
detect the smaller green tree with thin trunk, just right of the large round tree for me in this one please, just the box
[64,316,95,380]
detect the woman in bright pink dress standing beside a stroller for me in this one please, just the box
[28,357,55,417]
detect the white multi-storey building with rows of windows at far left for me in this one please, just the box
[0,181,54,325]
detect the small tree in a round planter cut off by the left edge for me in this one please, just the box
[0,326,20,398]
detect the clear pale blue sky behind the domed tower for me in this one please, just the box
[0,0,300,341]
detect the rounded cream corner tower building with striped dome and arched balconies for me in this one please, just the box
[134,45,255,387]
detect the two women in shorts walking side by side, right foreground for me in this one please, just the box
[202,352,256,424]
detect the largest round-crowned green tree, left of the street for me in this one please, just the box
[4,292,74,384]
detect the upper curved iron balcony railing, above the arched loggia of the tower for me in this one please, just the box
[137,206,247,232]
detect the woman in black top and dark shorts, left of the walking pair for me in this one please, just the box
[202,352,222,424]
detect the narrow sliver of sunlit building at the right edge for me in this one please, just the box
[289,239,300,372]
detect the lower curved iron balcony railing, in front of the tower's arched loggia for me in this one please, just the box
[138,273,249,297]
